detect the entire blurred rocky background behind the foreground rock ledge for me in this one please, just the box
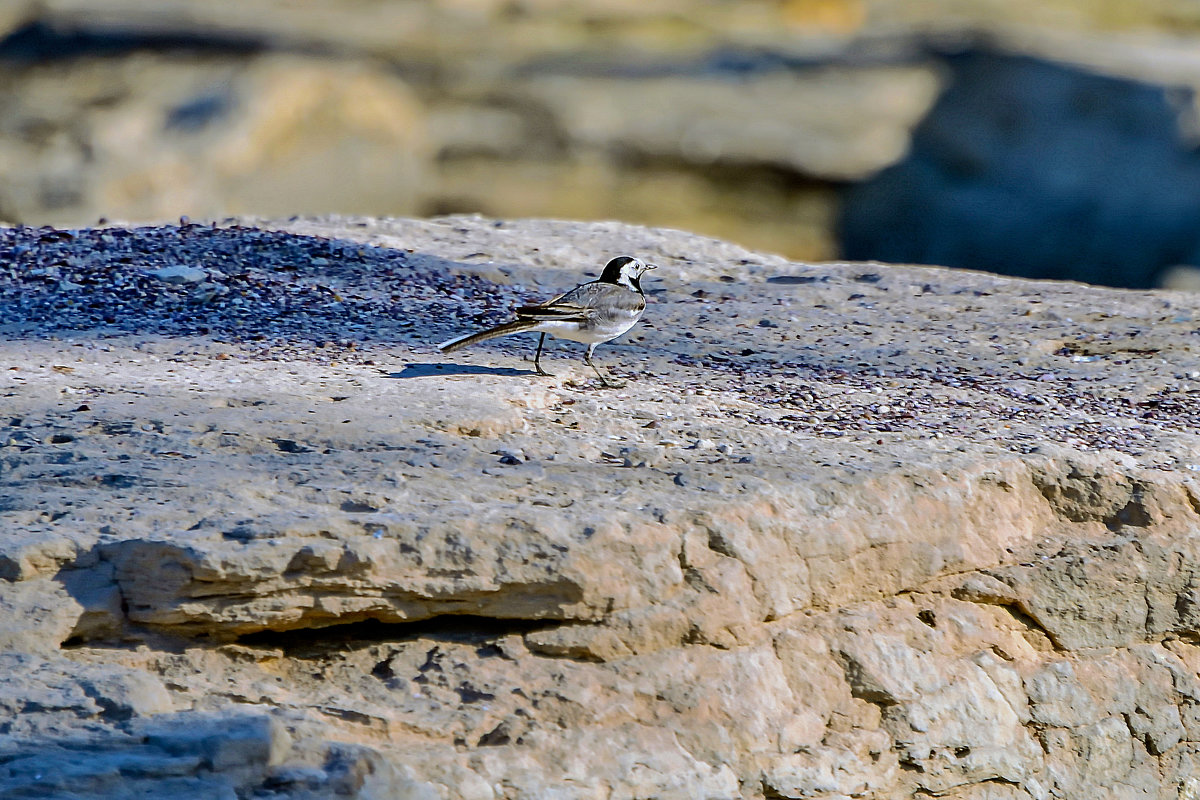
[7,0,1200,287]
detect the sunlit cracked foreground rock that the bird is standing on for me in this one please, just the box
[0,217,1200,800]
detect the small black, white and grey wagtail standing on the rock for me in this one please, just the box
[438,255,658,386]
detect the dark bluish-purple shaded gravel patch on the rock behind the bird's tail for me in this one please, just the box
[0,224,506,348]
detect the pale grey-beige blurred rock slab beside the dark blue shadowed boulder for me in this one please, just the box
[510,66,940,181]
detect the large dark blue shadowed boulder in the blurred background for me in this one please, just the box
[839,50,1200,288]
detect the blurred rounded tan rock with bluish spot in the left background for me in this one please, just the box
[0,53,425,225]
